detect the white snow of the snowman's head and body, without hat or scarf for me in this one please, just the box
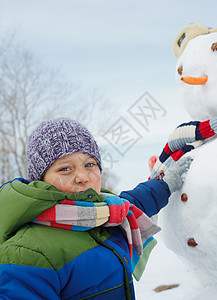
[160,27,217,282]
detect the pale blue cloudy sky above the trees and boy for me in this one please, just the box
[0,0,217,189]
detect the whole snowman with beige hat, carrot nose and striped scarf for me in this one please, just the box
[151,24,217,283]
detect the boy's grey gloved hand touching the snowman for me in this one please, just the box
[163,156,192,194]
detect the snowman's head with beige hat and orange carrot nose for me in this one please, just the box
[173,24,217,120]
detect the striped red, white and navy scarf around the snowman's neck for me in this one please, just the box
[149,117,217,179]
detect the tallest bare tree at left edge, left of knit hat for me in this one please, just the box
[0,44,70,182]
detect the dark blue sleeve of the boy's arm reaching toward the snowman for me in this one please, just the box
[119,178,170,217]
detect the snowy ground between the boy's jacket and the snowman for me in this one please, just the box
[134,234,217,300]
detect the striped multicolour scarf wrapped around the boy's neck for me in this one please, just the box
[33,195,160,280]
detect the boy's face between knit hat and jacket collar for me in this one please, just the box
[43,152,101,194]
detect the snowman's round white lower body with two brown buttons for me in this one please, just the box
[160,139,217,281]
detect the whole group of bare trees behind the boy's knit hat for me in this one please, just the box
[0,38,118,189]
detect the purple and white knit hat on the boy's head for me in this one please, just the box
[26,118,102,181]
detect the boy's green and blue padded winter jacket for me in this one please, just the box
[0,179,170,300]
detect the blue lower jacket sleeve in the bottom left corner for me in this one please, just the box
[0,264,60,300]
